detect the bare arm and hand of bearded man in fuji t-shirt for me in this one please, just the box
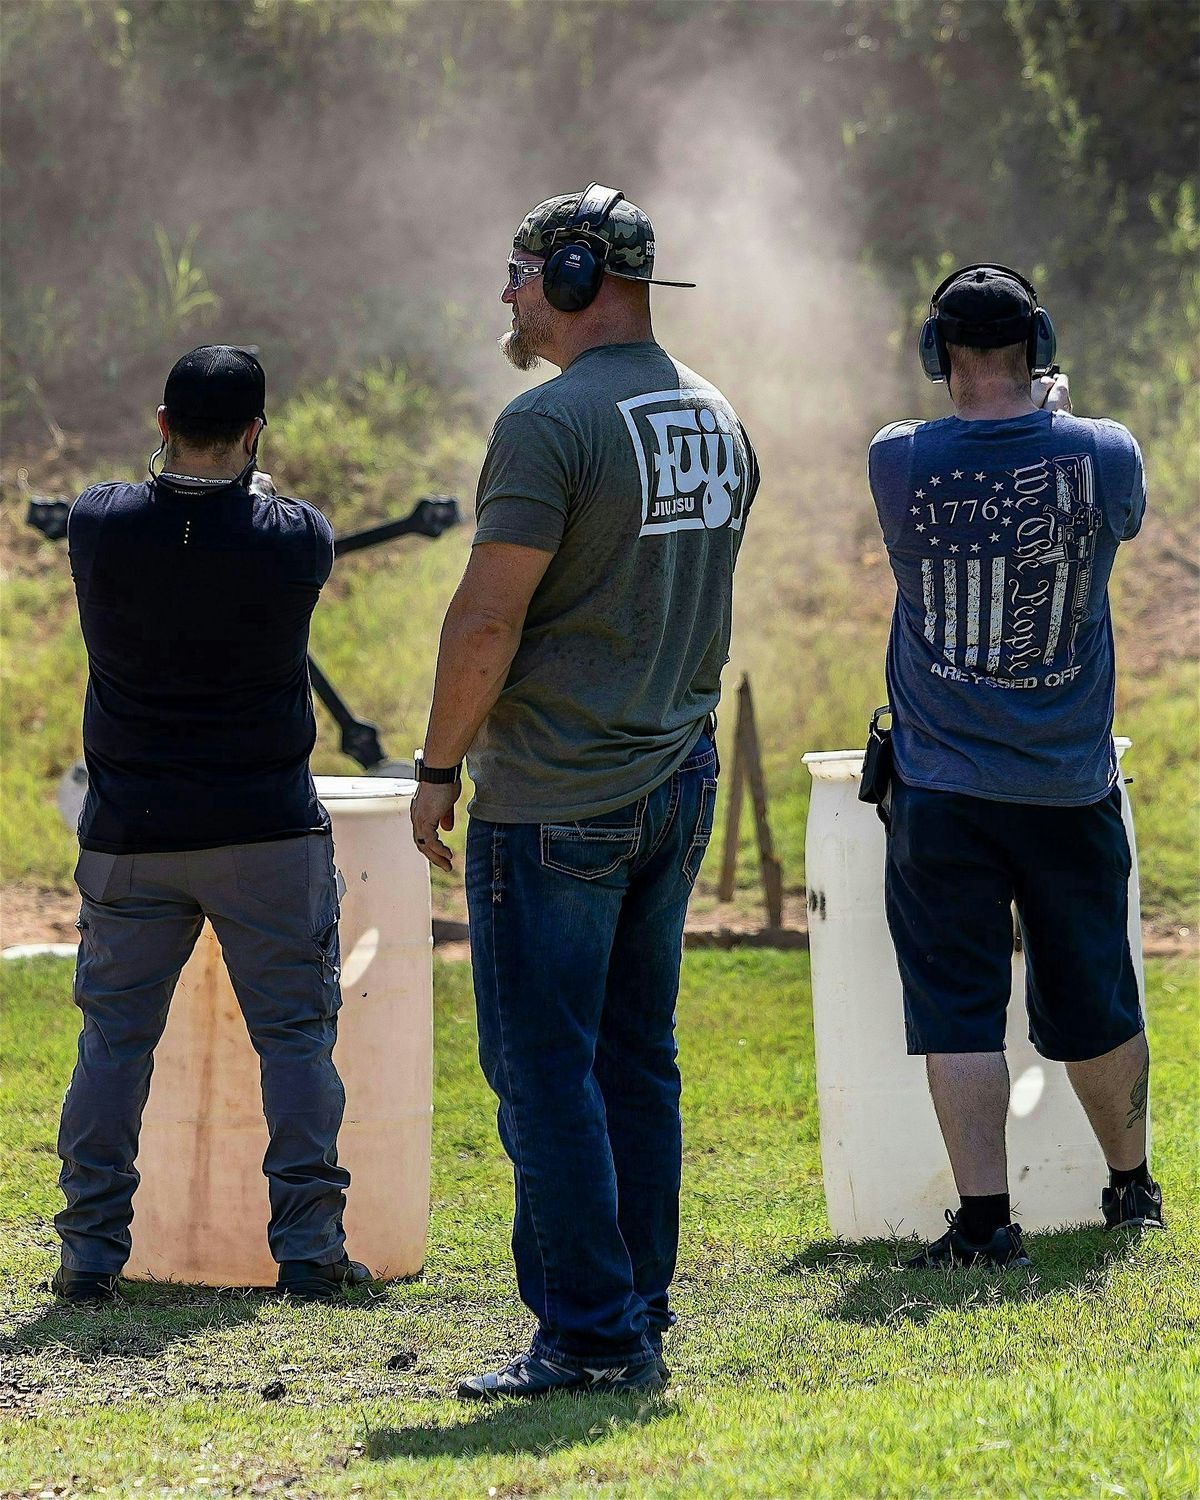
[413,542,552,870]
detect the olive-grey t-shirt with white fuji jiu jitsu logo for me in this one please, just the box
[468,342,759,824]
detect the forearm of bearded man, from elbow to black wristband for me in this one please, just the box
[425,600,521,767]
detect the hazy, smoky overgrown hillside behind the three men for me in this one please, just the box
[0,0,1200,912]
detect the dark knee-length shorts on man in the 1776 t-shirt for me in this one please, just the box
[885,777,1145,1062]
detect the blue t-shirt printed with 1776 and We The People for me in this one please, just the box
[867,411,1146,807]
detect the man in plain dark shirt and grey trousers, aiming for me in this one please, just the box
[54,345,368,1302]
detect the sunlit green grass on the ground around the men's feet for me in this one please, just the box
[0,953,1200,1500]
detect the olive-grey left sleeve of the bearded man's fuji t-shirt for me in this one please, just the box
[474,411,584,552]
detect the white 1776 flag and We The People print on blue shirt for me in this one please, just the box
[908,455,1103,687]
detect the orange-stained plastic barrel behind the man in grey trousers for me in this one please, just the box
[126,776,432,1286]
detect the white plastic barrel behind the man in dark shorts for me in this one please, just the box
[804,740,1145,1239]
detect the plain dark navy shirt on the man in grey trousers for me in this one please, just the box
[68,479,333,854]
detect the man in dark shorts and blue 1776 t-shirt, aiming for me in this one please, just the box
[869,266,1163,1268]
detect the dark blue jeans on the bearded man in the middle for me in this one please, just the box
[467,734,717,1368]
